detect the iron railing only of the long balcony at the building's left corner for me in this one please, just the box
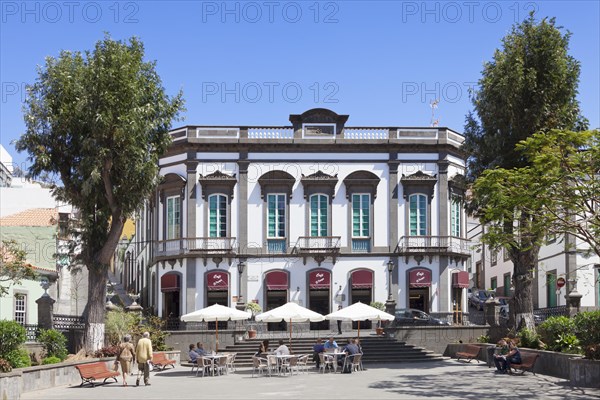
[154,237,237,257]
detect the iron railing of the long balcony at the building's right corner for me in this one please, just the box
[396,236,471,256]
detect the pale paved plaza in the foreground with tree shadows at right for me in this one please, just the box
[22,360,600,400]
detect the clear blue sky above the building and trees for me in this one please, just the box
[0,0,600,166]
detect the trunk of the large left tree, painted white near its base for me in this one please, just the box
[83,264,108,353]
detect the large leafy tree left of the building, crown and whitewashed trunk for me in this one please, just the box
[16,35,183,351]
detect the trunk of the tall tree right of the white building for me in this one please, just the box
[511,250,539,331]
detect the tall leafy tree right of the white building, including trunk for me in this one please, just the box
[464,13,587,330]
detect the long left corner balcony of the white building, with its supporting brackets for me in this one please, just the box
[154,237,237,265]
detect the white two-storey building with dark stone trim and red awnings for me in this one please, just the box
[131,109,470,324]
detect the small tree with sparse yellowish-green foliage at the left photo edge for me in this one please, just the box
[0,240,37,297]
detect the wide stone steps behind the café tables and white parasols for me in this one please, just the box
[221,335,444,367]
